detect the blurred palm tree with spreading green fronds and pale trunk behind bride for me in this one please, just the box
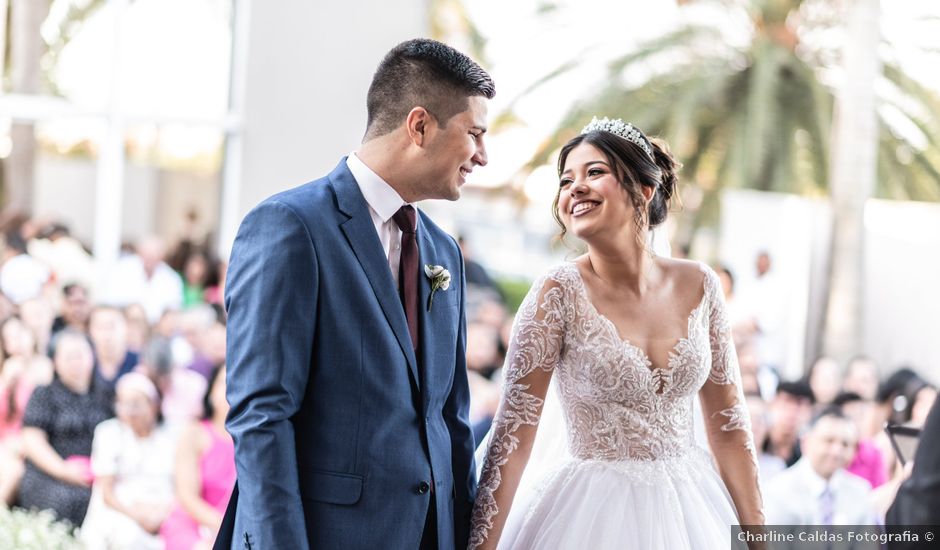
[504,0,940,368]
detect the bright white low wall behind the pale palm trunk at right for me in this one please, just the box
[719,190,940,383]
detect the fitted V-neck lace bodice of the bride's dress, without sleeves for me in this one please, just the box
[545,263,717,460]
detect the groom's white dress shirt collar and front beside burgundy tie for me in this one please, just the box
[346,153,417,287]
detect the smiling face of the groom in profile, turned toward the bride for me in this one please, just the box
[420,96,487,200]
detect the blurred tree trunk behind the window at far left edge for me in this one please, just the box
[3,0,49,213]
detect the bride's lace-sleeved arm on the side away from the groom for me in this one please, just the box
[700,268,764,525]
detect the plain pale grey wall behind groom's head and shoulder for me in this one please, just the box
[231,0,428,239]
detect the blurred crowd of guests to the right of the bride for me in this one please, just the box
[716,252,937,525]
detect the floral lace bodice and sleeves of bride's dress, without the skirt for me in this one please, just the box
[470,263,759,548]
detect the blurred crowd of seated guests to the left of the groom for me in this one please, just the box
[0,219,235,550]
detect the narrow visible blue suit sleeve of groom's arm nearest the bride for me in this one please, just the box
[444,248,477,548]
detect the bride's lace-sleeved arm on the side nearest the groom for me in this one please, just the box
[469,278,564,549]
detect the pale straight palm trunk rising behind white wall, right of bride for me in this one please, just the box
[823,0,881,361]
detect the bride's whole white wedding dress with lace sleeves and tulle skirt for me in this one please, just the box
[470,263,762,550]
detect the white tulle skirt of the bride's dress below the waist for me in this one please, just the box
[499,447,738,550]
